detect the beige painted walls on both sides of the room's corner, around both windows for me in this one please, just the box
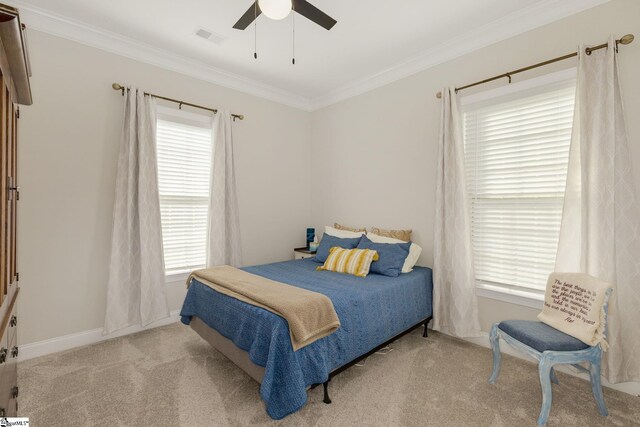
[19,0,640,344]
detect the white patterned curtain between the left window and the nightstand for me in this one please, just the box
[207,110,242,267]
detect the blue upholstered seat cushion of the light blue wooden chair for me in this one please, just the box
[498,320,589,353]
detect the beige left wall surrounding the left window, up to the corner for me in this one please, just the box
[19,31,310,344]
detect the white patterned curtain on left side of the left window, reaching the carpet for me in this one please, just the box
[103,88,169,334]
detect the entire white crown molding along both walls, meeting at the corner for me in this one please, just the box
[7,0,611,112]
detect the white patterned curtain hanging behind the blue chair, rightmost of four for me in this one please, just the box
[556,37,640,383]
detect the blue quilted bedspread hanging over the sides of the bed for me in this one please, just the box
[180,259,433,419]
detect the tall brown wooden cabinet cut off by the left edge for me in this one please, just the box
[0,4,32,417]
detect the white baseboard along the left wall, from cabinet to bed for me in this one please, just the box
[18,310,180,361]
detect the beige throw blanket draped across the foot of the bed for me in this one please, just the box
[187,265,340,351]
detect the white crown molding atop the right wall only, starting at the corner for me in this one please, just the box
[310,0,611,111]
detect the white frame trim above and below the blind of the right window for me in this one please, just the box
[460,67,577,309]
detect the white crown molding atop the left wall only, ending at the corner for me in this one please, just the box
[8,0,310,111]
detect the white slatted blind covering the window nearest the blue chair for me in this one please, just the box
[464,81,575,291]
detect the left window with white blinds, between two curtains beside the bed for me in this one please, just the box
[157,108,213,276]
